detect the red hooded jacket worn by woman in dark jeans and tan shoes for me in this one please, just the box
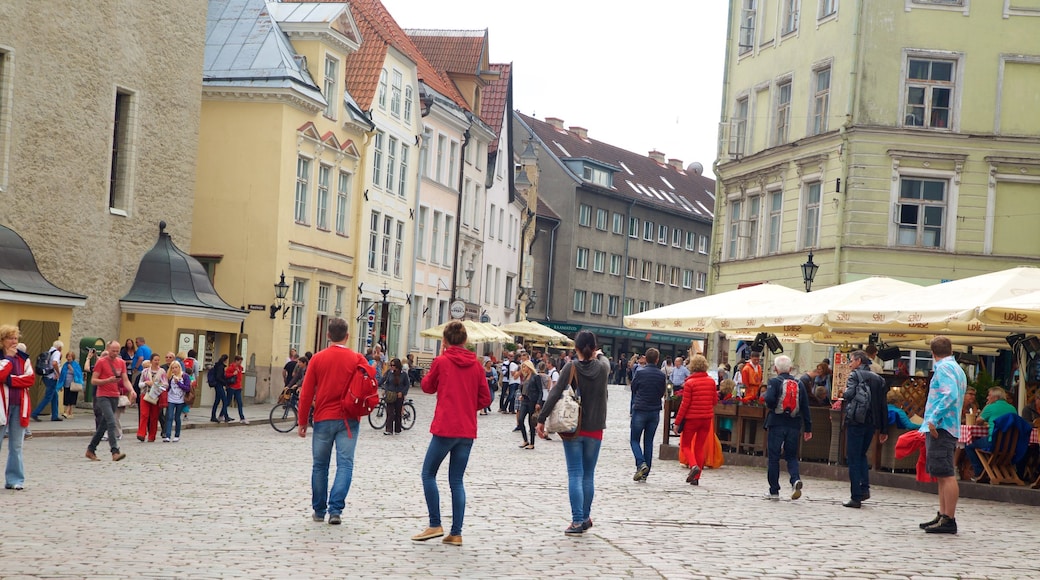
[422,346,491,439]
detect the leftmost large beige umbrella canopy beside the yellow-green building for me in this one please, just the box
[625,283,805,334]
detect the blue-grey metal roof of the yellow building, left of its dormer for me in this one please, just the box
[203,0,327,105]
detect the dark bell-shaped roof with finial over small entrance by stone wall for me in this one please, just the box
[121,221,241,312]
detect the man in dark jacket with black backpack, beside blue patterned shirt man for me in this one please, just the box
[841,350,888,508]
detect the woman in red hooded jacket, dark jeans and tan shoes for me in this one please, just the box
[412,320,491,546]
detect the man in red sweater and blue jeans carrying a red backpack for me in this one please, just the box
[298,318,375,526]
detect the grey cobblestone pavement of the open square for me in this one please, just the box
[0,387,1040,579]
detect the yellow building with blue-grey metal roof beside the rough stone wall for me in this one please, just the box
[191,0,373,401]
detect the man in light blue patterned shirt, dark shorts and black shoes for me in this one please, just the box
[920,336,967,533]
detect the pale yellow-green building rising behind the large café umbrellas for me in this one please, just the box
[710,0,1040,365]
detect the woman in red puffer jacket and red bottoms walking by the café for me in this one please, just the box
[675,354,719,485]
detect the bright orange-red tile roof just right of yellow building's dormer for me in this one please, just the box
[346,0,469,110]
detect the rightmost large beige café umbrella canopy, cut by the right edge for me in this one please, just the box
[826,266,1040,338]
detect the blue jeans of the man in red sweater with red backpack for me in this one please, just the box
[311,419,361,516]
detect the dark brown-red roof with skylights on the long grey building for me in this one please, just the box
[516,112,714,221]
